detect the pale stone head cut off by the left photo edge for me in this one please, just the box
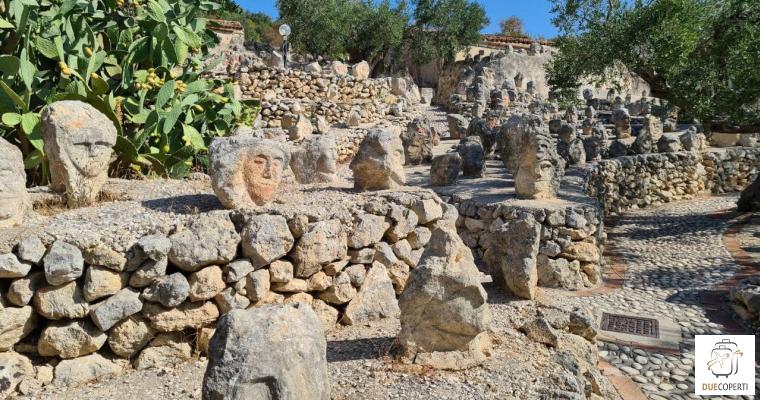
[0,138,31,228]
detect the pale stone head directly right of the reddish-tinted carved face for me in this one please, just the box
[290,135,338,183]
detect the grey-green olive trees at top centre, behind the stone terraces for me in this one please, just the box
[277,0,488,65]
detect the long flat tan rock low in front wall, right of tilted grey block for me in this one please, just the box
[143,301,219,332]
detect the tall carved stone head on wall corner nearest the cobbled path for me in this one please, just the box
[513,116,565,199]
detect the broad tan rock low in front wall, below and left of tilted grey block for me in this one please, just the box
[37,321,108,358]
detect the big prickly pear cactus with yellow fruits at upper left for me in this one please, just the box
[0,0,254,183]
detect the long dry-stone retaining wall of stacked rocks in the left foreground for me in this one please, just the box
[0,189,457,386]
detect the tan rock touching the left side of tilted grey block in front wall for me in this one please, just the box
[33,282,90,320]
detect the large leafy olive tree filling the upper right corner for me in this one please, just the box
[549,0,760,125]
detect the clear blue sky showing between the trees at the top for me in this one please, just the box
[236,0,557,38]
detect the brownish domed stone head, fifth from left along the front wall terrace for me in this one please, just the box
[350,129,406,190]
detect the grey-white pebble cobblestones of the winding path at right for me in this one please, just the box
[569,195,760,400]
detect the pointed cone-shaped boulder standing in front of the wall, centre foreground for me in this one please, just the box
[398,228,491,369]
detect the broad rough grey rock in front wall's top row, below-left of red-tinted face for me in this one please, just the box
[169,214,240,272]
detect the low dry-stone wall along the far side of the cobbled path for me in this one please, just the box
[586,148,760,215]
